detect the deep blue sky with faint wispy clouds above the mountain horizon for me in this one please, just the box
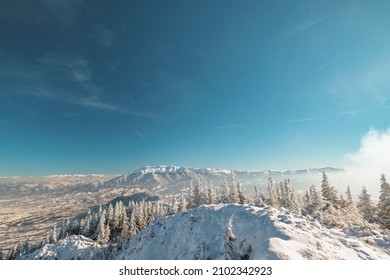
[0,0,390,176]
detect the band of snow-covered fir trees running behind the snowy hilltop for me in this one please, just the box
[0,172,390,259]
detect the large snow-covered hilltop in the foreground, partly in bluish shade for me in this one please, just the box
[116,204,390,260]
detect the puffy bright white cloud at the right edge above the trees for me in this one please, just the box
[345,129,390,172]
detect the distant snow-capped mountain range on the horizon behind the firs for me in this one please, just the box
[102,165,343,194]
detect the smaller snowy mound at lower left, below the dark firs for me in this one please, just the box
[23,235,104,260]
